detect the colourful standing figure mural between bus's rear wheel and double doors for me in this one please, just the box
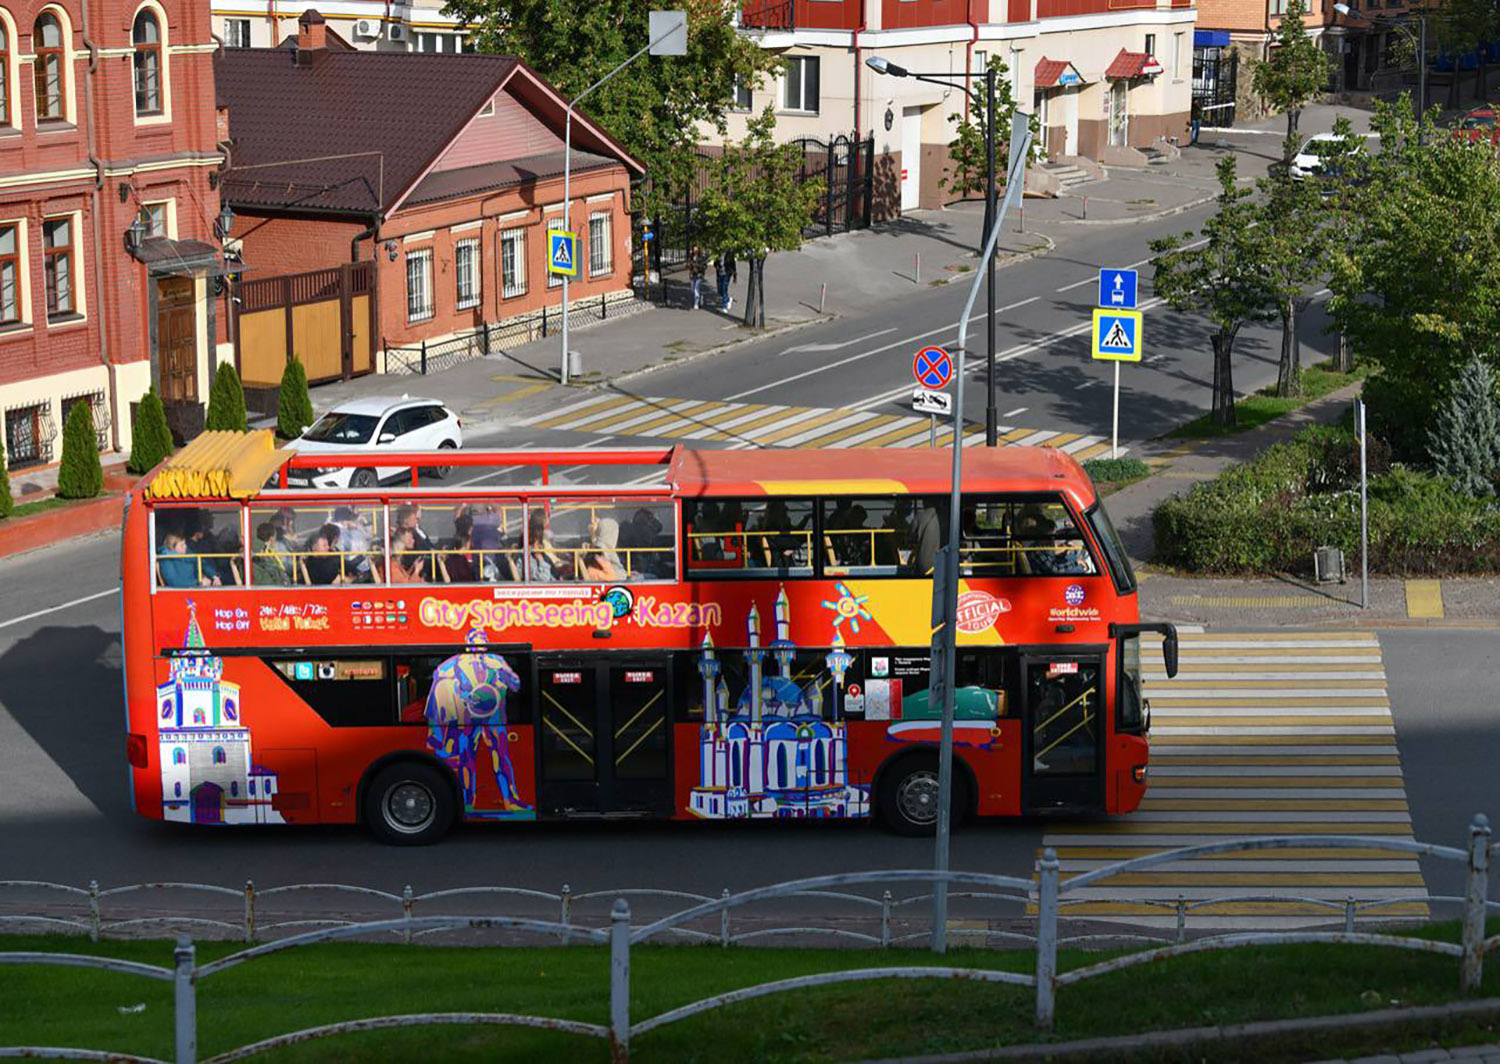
[425,629,533,816]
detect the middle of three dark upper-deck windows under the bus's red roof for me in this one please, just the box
[822,497,942,576]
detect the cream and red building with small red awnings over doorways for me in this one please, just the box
[731,0,1196,216]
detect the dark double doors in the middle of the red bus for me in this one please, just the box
[539,656,672,816]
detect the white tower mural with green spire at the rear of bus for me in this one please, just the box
[156,602,285,824]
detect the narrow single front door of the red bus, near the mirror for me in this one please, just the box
[1022,653,1104,810]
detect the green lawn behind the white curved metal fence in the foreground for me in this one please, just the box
[0,923,1500,1064]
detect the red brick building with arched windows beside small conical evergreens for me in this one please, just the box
[0,0,222,470]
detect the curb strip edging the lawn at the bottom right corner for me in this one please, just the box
[864,998,1500,1064]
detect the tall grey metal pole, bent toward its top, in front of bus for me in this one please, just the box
[932,111,1031,953]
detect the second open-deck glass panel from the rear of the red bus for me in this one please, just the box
[251,503,386,587]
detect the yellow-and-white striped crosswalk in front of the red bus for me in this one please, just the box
[1043,633,1427,929]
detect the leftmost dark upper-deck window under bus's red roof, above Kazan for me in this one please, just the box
[687,498,813,576]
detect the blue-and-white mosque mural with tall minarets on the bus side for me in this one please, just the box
[690,588,870,819]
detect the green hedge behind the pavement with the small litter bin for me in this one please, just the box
[1154,426,1500,575]
